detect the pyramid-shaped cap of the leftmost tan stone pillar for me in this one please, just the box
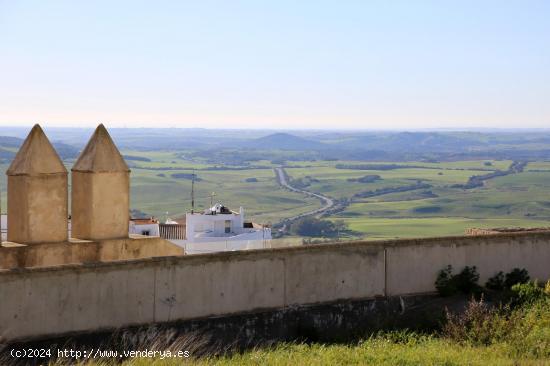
[6,124,67,176]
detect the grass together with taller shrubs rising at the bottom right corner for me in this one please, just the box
[48,294,550,366]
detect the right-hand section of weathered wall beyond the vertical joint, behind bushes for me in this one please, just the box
[386,233,550,295]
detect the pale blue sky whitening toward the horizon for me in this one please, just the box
[0,0,550,130]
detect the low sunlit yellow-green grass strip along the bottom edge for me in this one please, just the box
[125,337,543,366]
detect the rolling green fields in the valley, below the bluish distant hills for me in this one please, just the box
[0,154,550,240]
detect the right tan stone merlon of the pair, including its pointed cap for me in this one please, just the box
[71,124,130,240]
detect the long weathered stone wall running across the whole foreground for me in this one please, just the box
[0,233,550,339]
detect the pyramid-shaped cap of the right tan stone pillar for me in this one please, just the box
[71,124,130,173]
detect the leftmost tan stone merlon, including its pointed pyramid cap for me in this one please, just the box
[6,125,68,244]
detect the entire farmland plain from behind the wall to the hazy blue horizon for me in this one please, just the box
[4,130,550,241]
